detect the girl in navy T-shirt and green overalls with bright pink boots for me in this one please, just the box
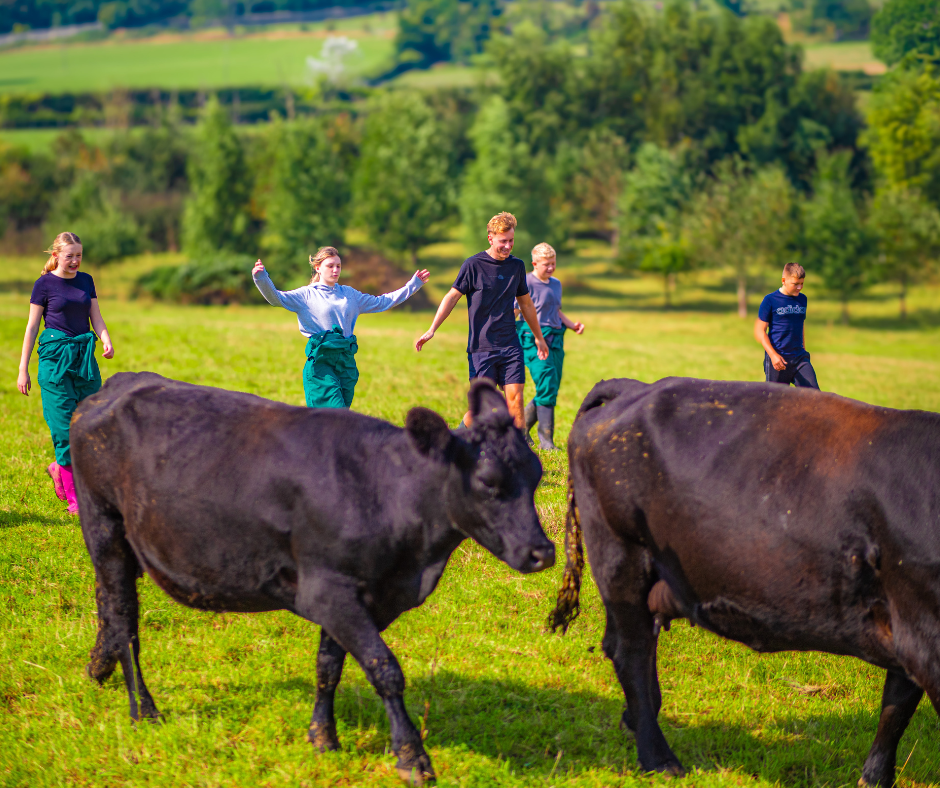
[16,233,114,514]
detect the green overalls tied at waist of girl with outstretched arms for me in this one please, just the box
[304,326,359,408]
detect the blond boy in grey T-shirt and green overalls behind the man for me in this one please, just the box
[516,243,584,450]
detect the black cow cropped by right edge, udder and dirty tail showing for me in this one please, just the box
[550,378,940,788]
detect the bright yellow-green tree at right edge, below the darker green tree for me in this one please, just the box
[864,66,940,206]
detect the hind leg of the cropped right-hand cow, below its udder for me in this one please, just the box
[604,599,684,775]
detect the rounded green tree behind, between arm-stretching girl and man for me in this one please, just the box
[353,92,454,265]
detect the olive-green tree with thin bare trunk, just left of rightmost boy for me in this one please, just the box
[686,159,796,317]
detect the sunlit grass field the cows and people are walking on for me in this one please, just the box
[0,247,940,788]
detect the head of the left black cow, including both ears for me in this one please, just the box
[405,380,555,573]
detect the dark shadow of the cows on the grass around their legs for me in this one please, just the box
[165,664,937,786]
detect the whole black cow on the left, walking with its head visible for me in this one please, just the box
[71,373,555,784]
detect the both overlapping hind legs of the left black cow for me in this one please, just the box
[78,496,160,720]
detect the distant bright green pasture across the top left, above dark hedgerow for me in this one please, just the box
[0,14,394,93]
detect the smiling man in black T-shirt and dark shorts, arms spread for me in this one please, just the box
[415,212,548,430]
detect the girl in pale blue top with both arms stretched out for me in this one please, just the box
[251,246,431,408]
